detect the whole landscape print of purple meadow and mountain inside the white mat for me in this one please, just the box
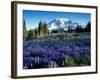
[22,10,91,69]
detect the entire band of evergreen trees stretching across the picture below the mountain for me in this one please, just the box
[23,20,91,40]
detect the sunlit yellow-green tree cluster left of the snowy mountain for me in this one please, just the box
[23,20,49,40]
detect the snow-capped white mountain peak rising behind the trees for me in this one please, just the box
[48,18,77,31]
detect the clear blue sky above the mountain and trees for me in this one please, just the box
[23,10,91,30]
